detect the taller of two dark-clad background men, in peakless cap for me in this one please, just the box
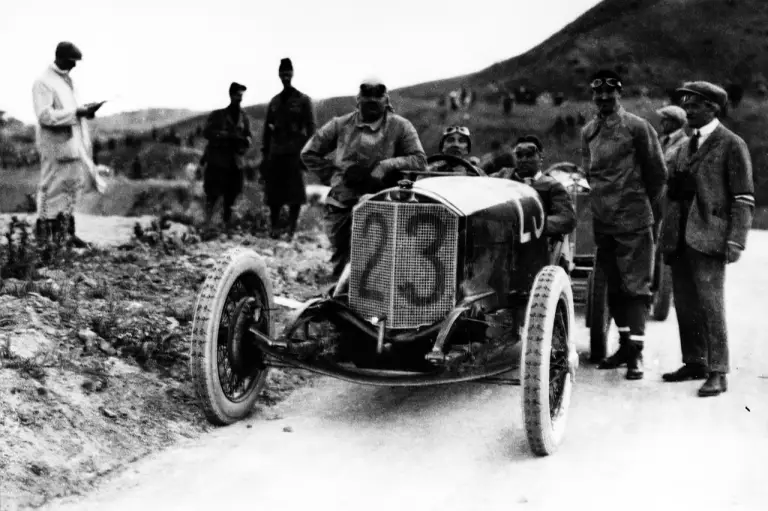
[261,58,315,239]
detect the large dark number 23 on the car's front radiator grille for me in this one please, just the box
[360,212,446,306]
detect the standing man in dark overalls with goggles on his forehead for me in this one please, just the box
[581,70,667,380]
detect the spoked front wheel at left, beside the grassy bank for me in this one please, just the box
[190,249,273,425]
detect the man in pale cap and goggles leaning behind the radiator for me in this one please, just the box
[301,78,427,280]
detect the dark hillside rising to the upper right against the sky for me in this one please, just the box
[402,0,768,98]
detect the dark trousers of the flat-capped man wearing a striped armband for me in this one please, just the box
[671,246,729,373]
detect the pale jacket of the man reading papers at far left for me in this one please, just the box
[32,65,91,162]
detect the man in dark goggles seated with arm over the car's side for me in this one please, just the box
[490,135,576,237]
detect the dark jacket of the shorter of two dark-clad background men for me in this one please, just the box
[203,108,253,168]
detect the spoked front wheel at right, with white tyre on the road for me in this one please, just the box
[523,266,578,456]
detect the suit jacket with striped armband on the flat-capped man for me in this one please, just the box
[660,120,755,256]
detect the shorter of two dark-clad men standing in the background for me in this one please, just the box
[203,82,252,228]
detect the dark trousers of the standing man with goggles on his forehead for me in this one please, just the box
[595,227,654,342]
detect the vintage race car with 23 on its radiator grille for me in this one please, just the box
[190,158,578,455]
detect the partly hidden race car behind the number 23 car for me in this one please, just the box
[545,162,672,362]
